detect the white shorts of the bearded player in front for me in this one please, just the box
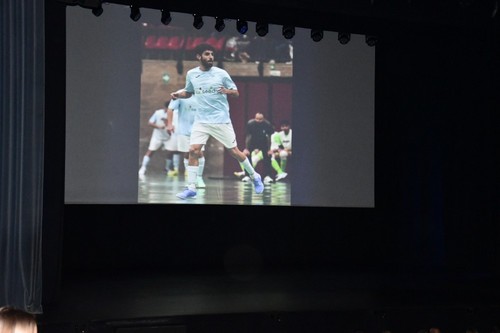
[190,122,237,149]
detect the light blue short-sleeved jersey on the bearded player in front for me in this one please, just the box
[185,67,237,124]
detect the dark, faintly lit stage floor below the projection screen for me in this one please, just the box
[41,270,500,333]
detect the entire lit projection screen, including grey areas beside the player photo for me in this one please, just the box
[64,4,375,207]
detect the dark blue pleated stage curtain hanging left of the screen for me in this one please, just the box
[0,0,45,313]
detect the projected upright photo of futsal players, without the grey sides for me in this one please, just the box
[138,14,293,205]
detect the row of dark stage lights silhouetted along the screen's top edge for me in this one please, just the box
[92,5,377,46]
